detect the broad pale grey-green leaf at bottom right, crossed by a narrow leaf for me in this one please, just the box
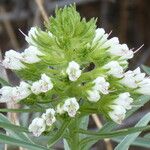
[115,113,150,150]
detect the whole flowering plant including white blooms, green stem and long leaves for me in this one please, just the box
[0,6,150,150]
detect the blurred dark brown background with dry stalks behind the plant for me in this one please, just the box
[0,0,150,150]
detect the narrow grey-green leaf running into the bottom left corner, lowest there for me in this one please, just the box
[0,134,49,150]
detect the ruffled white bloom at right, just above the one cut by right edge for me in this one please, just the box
[120,67,145,88]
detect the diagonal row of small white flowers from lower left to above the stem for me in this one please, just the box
[29,98,79,136]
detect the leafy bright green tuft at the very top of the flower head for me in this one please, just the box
[46,5,96,50]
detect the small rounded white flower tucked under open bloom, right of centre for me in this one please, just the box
[87,90,100,102]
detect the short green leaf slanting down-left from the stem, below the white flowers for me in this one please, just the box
[48,120,71,147]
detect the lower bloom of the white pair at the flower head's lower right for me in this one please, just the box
[109,105,126,124]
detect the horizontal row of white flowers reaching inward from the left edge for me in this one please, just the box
[0,74,53,103]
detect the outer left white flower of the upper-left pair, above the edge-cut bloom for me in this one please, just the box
[2,50,25,70]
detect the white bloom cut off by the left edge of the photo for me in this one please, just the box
[0,86,13,103]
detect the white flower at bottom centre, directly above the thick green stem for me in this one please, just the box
[63,97,79,117]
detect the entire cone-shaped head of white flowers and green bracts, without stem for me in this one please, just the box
[0,7,150,136]
